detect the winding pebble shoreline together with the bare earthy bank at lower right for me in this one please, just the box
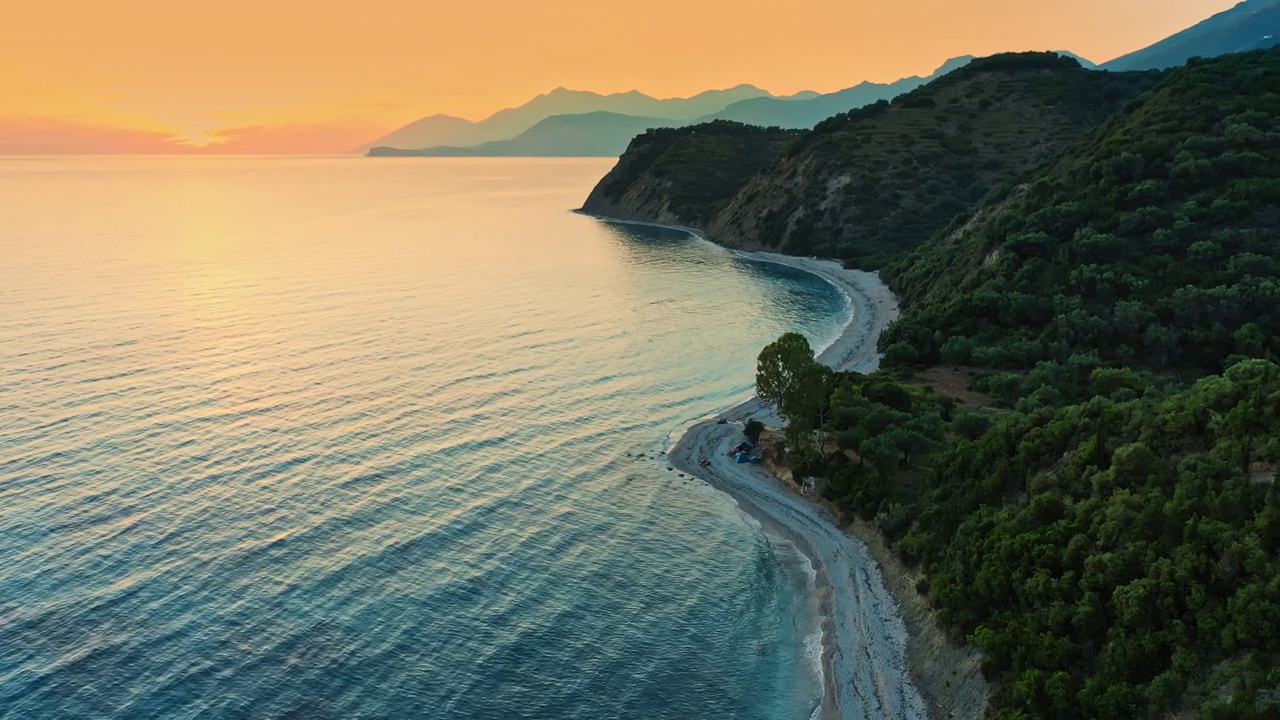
[593,215,987,720]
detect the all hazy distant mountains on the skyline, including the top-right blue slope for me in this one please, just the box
[357,0,1280,156]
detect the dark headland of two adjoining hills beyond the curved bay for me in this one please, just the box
[584,53,1161,260]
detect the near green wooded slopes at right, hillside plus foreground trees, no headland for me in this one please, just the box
[758,50,1280,719]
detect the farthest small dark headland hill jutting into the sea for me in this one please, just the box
[582,120,803,227]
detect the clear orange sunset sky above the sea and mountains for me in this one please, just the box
[0,0,1235,154]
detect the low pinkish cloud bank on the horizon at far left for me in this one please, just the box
[0,115,191,155]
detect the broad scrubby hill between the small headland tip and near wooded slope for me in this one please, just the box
[732,53,1158,265]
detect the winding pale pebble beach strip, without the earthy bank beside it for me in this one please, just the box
[586,212,933,720]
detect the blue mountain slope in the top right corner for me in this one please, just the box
[1102,0,1280,70]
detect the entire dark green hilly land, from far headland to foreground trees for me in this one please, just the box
[585,49,1280,720]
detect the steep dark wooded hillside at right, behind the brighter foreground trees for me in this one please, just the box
[886,50,1280,373]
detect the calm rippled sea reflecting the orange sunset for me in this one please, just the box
[0,158,845,720]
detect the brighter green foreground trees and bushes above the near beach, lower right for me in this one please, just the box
[771,351,1280,719]
